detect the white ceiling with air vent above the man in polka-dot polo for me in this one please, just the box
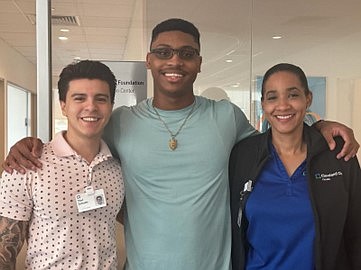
[0,0,134,79]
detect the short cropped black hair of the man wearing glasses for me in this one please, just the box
[150,18,200,47]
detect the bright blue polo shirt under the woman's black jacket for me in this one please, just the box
[245,146,315,270]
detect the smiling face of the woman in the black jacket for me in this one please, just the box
[262,71,312,135]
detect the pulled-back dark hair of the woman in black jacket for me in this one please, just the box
[261,63,311,100]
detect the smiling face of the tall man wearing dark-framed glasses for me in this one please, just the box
[147,31,202,104]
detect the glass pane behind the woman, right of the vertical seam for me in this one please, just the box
[252,0,361,141]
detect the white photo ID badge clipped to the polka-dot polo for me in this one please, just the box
[75,186,107,213]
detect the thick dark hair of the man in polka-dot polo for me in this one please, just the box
[58,60,116,104]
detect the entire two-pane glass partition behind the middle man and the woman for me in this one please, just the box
[146,0,361,157]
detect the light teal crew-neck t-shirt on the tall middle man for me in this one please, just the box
[104,97,256,270]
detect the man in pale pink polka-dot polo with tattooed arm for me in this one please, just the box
[0,60,124,270]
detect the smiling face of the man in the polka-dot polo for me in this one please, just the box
[60,79,113,145]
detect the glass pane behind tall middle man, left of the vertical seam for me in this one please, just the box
[146,0,253,120]
